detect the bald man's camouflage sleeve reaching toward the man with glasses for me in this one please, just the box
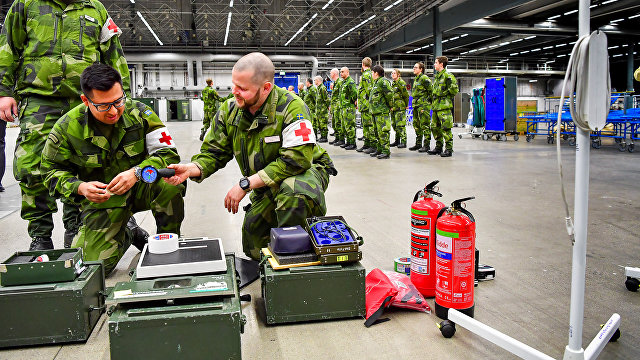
[191,101,238,182]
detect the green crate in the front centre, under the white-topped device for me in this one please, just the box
[109,255,246,360]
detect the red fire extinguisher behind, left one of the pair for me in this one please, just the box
[410,180,445,297]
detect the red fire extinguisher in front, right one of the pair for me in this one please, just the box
[435,197,476,320]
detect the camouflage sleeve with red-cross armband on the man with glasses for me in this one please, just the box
[138,103,180,169]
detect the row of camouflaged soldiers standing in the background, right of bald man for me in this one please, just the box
[299,56,458,159]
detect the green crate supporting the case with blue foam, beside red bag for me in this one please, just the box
[260,261,365,324]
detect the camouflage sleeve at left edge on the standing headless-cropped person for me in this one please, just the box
[0,0,27,96]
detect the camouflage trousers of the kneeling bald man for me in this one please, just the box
[242,164,329,260]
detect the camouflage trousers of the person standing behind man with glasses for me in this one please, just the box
[13,96,80,238]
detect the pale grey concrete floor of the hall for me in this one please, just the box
[0,122,640,359]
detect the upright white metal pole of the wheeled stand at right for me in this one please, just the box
[558,0,590,359]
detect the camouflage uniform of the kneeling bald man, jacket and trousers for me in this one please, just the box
[191,86,337,259]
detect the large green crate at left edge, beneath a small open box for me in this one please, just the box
[0,262,105,348]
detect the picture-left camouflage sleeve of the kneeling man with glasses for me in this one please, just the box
[40,123,82,200]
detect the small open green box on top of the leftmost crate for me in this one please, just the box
[0,249,82,286]
